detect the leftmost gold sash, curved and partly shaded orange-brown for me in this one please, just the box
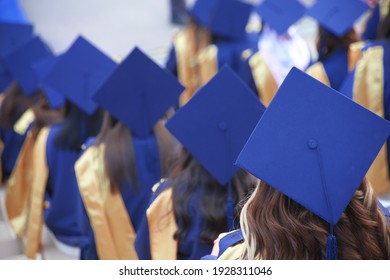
[5,131,39,239]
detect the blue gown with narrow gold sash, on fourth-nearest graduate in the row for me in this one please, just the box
[25,124,87,259]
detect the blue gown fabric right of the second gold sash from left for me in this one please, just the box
[44,124,87,247]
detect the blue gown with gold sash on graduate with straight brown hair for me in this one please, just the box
[75,134,161,259]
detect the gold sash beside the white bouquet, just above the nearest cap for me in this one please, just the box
[249,52,278,107]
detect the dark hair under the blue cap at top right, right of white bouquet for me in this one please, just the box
[317,26,359,60]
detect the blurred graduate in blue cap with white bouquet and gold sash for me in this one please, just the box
[241,0,312,106]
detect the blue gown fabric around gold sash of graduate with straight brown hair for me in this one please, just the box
[81,134,161,259]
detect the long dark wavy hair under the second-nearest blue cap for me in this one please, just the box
[170,148,255,245]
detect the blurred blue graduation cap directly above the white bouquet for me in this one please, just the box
[256,0,306,35]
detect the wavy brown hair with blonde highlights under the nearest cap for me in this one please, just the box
[241,179,390,260]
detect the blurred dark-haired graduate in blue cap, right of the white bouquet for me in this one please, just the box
[306,0,369,90]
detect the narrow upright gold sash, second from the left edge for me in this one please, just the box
[25,127,49,259]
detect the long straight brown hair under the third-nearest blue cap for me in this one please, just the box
[95,112,176,191]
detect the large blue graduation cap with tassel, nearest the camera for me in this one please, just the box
[237,68,390,258]
